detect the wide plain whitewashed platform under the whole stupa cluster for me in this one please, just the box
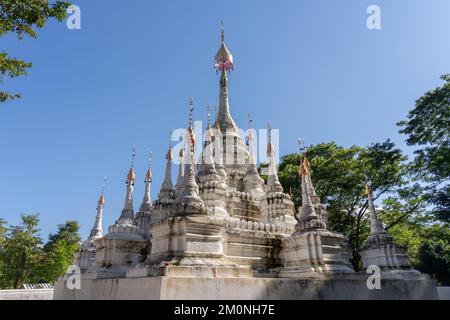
[53,274,438,300]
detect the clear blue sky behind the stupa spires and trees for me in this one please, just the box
[0,0,450,238]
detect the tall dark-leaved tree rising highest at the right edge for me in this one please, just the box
[398,74,450,222]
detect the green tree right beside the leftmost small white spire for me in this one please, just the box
[39,221,81,283]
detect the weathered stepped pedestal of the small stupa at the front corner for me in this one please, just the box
[127,210,252,277]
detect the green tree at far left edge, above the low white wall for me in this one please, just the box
[0,214,43,288]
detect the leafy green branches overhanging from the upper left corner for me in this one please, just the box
[0,0,70,102]
